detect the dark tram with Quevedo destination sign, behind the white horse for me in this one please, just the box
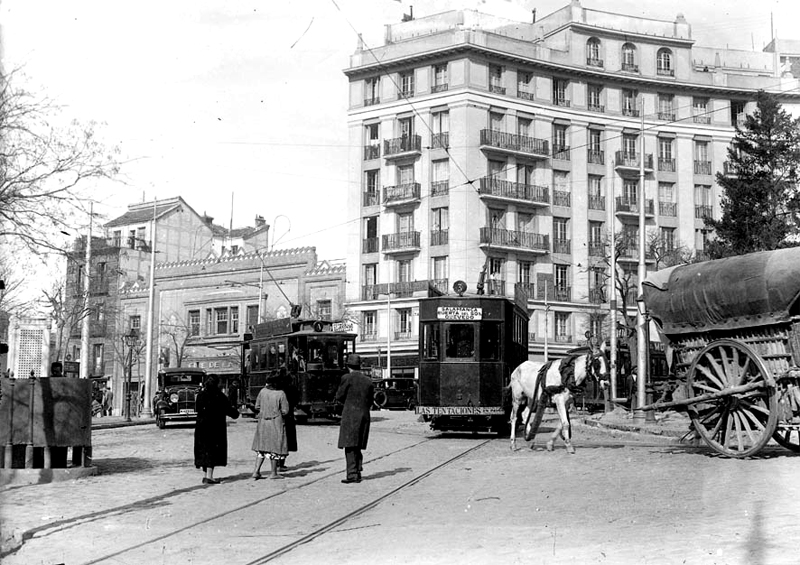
[414,281,529,434]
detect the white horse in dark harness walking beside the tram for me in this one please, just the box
[508,343,609,453]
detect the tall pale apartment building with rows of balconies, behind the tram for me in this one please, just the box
[345,1,800,373]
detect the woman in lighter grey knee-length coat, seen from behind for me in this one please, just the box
[252,374,289,480]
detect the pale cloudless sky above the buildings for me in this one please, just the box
[0,0,800,259]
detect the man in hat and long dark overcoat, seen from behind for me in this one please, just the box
[336,353,375,484]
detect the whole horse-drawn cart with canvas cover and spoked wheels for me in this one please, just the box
[643,248,800,457]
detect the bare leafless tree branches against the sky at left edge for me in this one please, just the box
[0,72,119,253]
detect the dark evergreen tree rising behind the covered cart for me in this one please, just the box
[704,91,800,258]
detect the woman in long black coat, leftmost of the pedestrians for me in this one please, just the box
[194,375,239,485]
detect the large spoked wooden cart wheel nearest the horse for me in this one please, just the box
[687,339,778,457]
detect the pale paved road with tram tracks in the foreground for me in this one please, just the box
[0,412,800,565]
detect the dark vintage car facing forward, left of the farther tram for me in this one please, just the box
[153,367,206,429]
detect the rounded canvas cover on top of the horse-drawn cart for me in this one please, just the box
[642,247,800,335]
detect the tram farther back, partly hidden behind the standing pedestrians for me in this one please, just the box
[245,318,356,421]
